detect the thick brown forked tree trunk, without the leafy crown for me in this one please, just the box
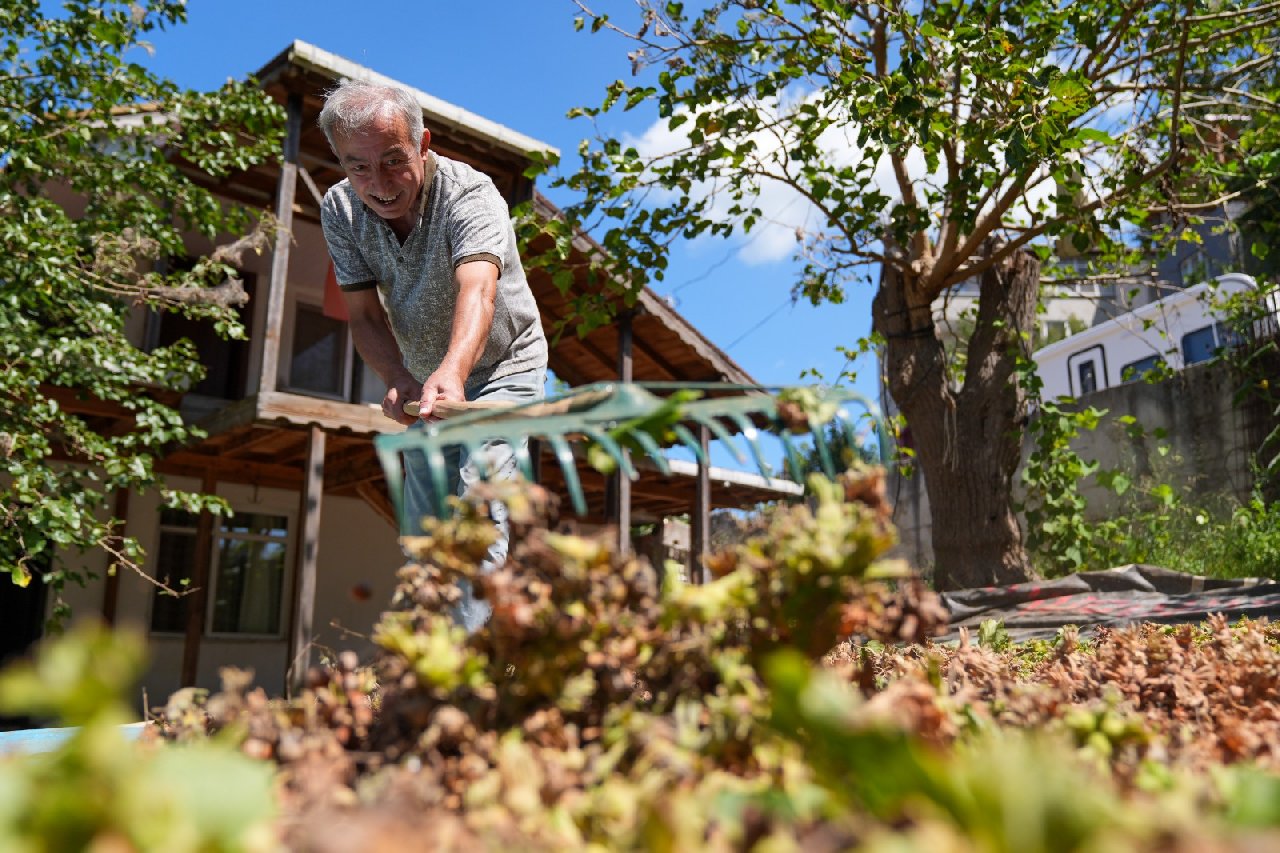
[872,252,1039,589]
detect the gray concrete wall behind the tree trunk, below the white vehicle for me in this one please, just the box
[888,364,1280,574]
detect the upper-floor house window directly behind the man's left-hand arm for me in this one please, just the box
[288,302,387,403]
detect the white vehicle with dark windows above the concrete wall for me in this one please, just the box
[1034,273,1277,400]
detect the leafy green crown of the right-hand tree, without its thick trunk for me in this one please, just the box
[545,0,1280,295]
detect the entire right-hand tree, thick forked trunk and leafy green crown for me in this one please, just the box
[526,0,1280,585]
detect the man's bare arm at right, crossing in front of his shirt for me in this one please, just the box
[420,260,498,418]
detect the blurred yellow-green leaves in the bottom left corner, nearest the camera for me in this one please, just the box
[0,628,278,853]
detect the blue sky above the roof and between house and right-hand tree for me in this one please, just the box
[140,0,876,414]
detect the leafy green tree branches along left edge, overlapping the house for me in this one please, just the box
[0,0,283,612]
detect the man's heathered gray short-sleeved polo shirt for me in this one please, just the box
[320,151,547,387]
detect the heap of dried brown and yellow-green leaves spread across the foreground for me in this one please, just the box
[0,470,1280,853]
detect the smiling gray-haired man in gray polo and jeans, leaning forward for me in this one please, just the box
[320,81,547,631]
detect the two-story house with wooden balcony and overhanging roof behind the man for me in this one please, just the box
[0,42,799,703]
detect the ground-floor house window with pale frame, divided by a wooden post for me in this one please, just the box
[151,510,289,637]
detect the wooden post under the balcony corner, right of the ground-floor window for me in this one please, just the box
[289,425,325,695]
